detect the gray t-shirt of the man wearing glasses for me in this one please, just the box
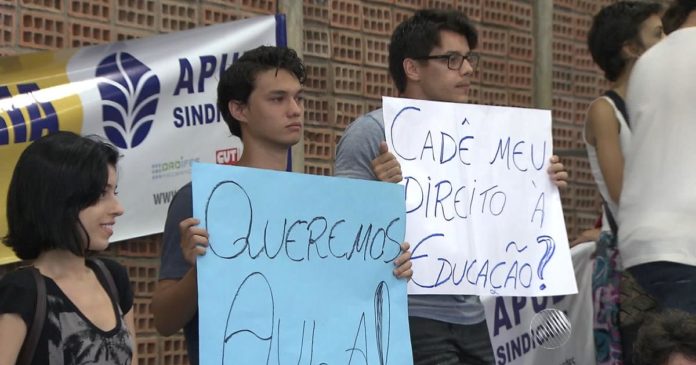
[335,109,485,325]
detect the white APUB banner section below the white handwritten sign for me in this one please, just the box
[481,242,596,365]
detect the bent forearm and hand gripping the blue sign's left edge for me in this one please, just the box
[152,218,208,336]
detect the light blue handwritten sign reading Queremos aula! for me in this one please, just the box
[193,164,412,364]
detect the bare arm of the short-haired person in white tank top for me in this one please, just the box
[585,98,624,204]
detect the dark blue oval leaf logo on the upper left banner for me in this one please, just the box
[96,52,160,149]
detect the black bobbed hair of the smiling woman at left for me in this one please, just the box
[3,132,119,260]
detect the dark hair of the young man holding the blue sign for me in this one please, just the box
[217,46,306,139]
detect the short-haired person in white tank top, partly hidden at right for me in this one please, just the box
[584,1,664,364]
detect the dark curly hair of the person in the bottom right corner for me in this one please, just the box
[633,310,696,365]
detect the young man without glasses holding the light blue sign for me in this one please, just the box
[152,46,412,364]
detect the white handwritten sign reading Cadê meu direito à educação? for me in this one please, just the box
[383,97,577,296]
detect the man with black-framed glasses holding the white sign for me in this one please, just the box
[336,9,567,365]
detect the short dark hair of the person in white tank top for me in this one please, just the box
[587,1,662,81]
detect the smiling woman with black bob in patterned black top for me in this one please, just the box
[0,132,137,364]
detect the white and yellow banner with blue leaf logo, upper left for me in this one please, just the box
[0,16,285,264]
